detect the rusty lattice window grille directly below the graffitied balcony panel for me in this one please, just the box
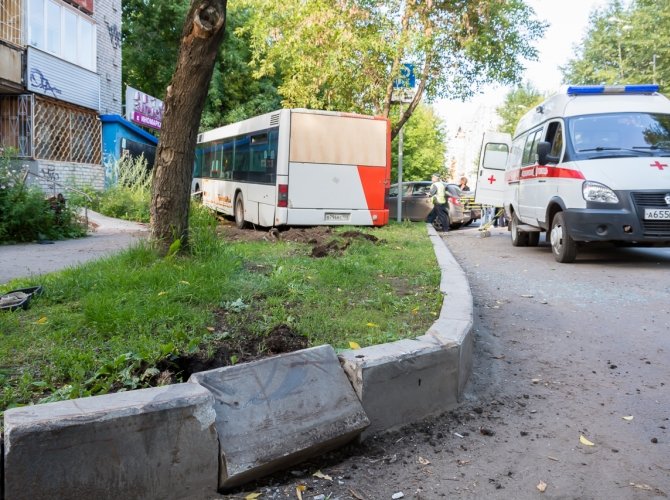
[34,97,102,164]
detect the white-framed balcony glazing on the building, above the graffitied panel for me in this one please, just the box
[27,0,96,71]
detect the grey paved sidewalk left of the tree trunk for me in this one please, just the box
[0,210,149,285]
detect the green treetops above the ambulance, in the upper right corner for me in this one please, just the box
[561,0,670,92]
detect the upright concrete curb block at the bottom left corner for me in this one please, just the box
[4,384,218,500]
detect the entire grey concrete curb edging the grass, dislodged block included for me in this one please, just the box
[0,225,473,500]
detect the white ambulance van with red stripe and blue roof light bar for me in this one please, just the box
[504,85,670,262]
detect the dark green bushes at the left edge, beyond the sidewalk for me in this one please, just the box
[0,150,86,243]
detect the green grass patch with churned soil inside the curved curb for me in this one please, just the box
[0,215,442,411]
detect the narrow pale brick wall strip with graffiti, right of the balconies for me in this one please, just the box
[93,0,123,115]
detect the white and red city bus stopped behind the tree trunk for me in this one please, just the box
[192,109,391,228]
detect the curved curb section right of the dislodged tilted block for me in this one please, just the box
[340,224,473,439]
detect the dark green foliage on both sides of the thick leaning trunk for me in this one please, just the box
[122,0,280,130]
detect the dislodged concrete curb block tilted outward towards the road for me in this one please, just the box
[189,345,369,488]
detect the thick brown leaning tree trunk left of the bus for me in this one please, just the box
[151,0,227,255]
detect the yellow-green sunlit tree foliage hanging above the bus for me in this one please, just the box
[238,0,544,114]
